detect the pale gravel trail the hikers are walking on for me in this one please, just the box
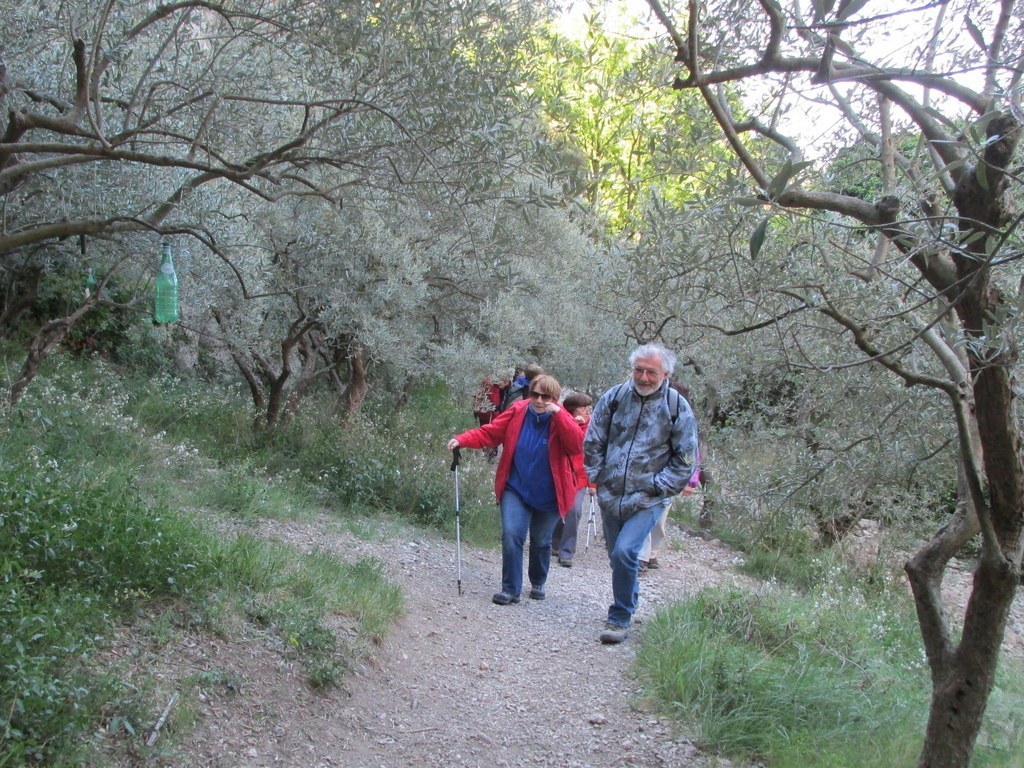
[159,514,753,768]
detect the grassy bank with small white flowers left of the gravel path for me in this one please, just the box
[0,356,402,766]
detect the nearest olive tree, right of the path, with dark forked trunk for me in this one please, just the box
[648,0,1024,767]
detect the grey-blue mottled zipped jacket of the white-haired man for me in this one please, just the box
[583,379,697,520]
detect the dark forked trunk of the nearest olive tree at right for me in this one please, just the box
[906,337,1024,768]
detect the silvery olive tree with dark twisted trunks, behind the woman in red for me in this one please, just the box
[168,2,614,422]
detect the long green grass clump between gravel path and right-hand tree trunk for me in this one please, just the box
[637,591,928,768]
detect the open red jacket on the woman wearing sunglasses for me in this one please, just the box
[455,400,583,517]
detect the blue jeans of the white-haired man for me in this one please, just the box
[601,499,672,627]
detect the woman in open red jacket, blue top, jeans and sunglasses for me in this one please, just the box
[447,374,583,605]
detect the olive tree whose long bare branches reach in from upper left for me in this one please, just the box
[0,0,389,400]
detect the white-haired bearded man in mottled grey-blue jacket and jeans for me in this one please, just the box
[584,344,697,643]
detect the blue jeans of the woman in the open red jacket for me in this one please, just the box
[499,490,561,596]
